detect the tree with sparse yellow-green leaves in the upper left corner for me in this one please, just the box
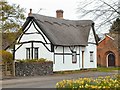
[0,0,25,32]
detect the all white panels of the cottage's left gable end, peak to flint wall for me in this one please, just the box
[15,21,53,61]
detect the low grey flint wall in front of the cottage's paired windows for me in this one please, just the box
[15,62,53,76]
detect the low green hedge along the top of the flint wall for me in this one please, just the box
[17,58,51,63]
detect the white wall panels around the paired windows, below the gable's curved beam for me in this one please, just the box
[15,43,53,61]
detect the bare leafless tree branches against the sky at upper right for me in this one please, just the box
[77,0,120,33]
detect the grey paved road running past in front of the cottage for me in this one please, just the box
[2,72,118,88]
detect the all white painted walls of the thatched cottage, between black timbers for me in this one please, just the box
[15,20,97,71]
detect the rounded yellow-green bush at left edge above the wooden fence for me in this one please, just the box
[0,50,13,63]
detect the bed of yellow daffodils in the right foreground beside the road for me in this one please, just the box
[56,75,120,90]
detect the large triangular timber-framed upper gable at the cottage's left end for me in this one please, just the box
[17,20,50,43]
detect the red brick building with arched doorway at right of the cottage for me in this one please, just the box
[97,34,120,67]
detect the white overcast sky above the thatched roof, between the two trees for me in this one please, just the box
[7,0,79,20]
